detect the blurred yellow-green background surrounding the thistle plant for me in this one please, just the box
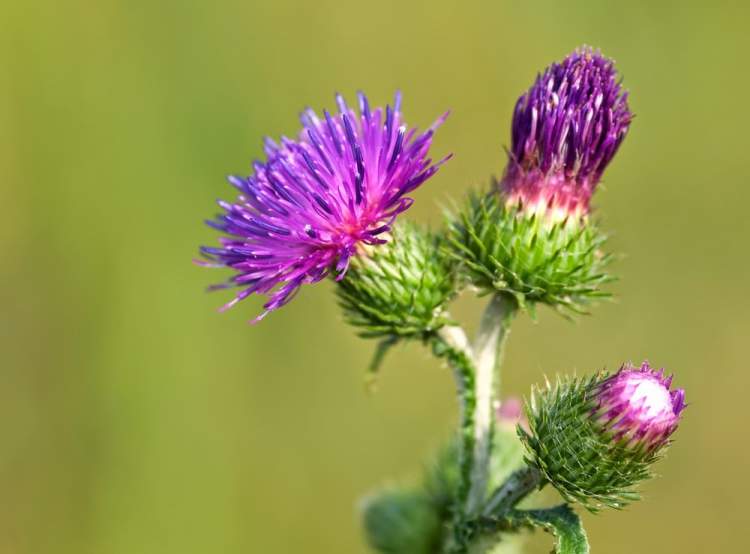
[0,0,750,554]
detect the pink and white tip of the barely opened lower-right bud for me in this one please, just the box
[592,362,685,452]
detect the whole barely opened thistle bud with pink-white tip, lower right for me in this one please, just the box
[518,362,685,511]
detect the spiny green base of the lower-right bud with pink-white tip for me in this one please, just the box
[518,373,658,512]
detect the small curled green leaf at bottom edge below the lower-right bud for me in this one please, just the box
[509,504,589,554]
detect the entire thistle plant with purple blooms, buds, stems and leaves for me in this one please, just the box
[198,48,685,554]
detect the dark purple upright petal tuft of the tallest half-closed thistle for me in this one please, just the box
[500,47,632,220]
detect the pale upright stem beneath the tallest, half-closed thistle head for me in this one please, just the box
[465,293,517,516]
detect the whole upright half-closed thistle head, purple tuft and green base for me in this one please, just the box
[450,48,632,311]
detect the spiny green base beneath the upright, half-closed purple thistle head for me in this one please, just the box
[448,193,612,312]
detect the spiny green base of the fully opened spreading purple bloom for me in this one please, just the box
[338,224,456,339]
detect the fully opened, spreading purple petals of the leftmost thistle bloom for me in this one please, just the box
[198,89,450,322]
